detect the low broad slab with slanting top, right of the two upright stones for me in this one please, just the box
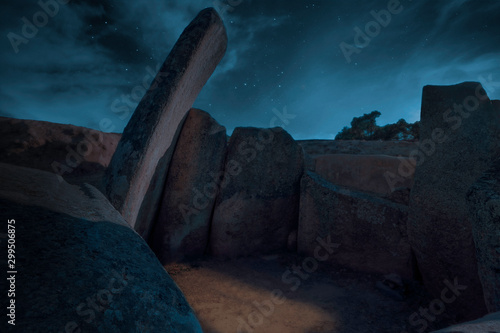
[297,172,413,278]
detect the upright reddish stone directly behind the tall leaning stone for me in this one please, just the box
[149,109,227,264]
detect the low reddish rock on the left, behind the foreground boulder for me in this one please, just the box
[0,117,121,185]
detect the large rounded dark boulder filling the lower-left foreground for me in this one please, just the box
[0,164,201,332]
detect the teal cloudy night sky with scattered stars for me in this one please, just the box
[0,0,500,139]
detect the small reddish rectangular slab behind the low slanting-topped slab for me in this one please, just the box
[315,154,415,195]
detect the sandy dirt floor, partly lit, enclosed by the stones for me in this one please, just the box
[165,254,458,333]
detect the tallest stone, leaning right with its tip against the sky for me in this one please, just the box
[105,8,227,238]
